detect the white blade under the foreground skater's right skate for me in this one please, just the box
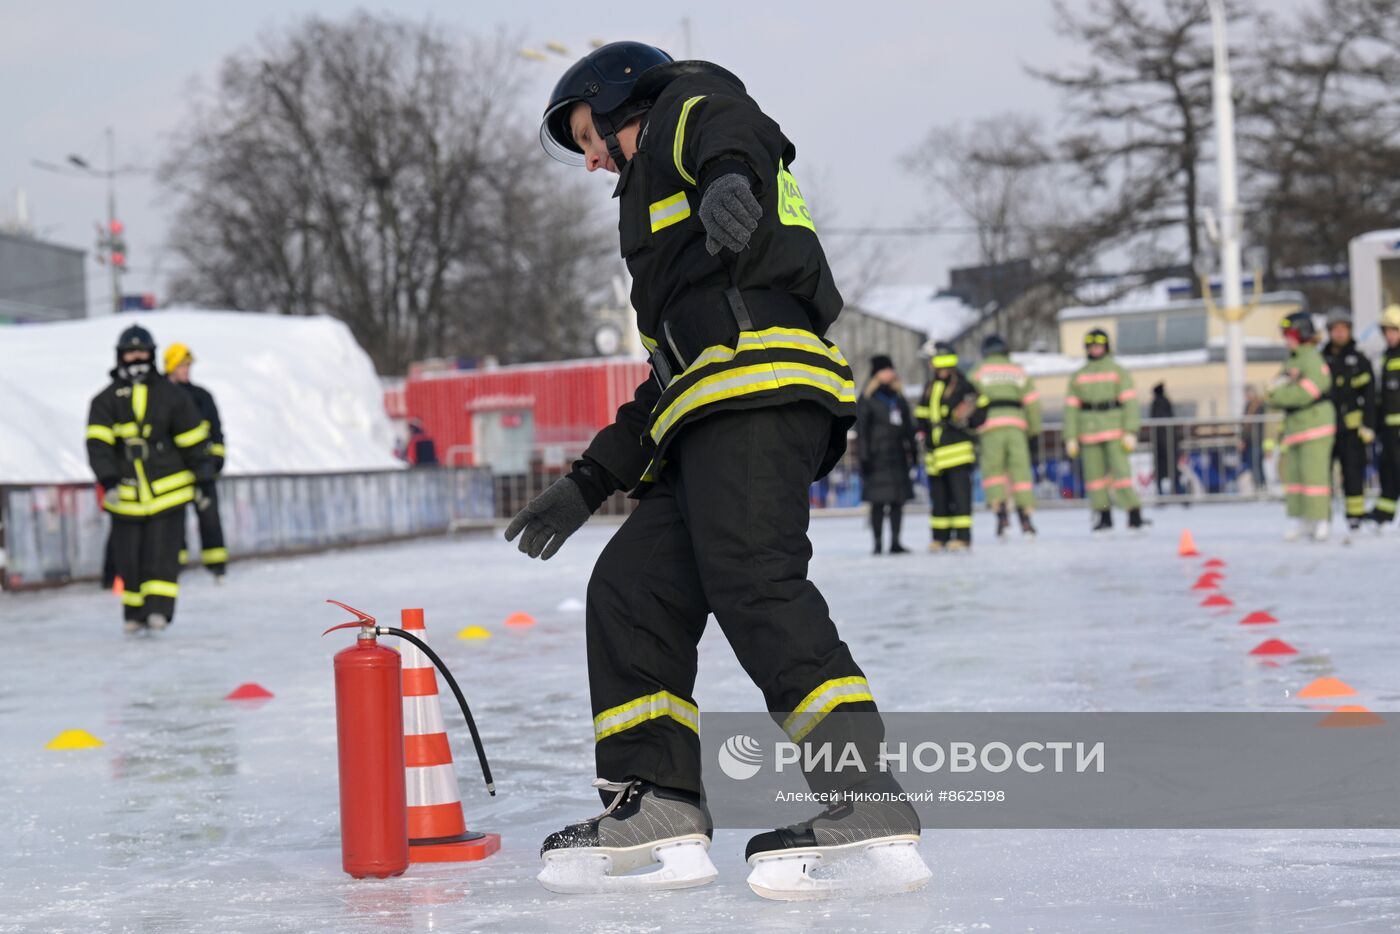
[749,833,934,902]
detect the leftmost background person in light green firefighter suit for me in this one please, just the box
[972,335,1040,538]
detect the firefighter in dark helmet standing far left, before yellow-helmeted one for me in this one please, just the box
[87,325,213,633]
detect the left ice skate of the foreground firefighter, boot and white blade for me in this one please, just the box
[538,781,718,895]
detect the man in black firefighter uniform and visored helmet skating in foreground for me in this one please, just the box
[507,42,917,885]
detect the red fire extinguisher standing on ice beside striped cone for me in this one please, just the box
[326,601,409,879]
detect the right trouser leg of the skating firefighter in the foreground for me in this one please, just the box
[672,402,883,790]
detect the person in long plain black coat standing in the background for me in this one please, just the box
[855,354,918,555]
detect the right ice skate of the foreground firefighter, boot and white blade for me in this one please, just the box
[746,802,932,902]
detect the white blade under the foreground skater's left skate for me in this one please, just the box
[536,833,720,895]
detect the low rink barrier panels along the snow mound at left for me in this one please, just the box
[0,468,497,590]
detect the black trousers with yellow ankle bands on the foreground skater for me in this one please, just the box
[588,402,883,794]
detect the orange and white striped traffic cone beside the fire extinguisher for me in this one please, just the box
[399,609,501,863]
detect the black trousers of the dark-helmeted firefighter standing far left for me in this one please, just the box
[111,506,185,623]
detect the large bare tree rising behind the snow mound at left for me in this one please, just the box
[161,13,599,371]
